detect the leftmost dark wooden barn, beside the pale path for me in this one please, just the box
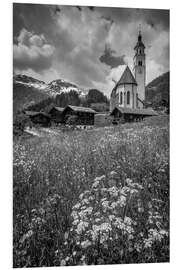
[25,111,51,127]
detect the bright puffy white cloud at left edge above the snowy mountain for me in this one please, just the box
[13,29,54,72]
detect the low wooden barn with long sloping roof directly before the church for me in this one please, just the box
[110,107,158,124]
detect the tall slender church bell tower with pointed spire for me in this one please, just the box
[134,30,146,108]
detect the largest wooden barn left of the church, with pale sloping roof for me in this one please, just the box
[62,105,96,125]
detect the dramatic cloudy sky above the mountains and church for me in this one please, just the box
[13,4,169,95]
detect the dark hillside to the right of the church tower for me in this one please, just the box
[145,71,170,109]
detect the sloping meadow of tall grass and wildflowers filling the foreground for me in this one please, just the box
[13,116,169,267]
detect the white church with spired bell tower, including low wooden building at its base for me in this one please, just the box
[110,31,157,121]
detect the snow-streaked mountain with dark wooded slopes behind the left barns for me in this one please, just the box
[13,75,108,114]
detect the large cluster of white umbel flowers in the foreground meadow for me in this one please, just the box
[59,171,168,265]
